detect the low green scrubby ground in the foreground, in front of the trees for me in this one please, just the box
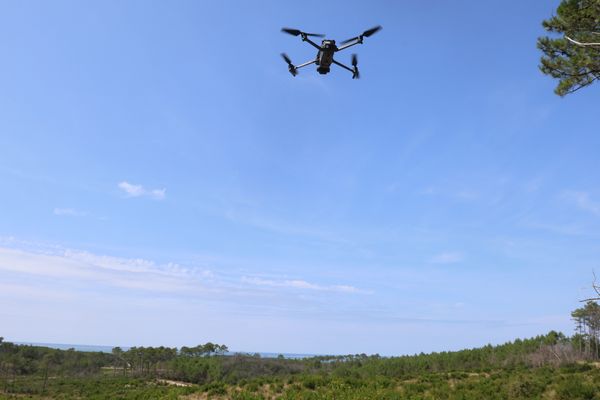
[0,366,600,400]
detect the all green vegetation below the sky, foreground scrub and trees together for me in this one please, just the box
[0,328,600,400]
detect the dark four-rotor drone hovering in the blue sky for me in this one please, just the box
[281,26,381,79]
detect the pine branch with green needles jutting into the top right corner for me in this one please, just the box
[538,0,600,96]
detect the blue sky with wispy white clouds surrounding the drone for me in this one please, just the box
[0,0,600,355]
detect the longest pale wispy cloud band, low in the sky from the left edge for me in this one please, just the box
[0,238,364,298]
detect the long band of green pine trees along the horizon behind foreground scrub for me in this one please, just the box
[0,331,587,390]
